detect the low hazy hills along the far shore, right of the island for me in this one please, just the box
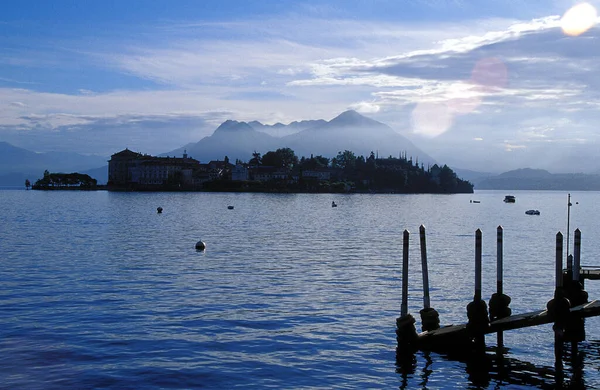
[473,168,600,191]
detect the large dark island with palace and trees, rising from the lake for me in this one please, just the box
[107,148,473,194]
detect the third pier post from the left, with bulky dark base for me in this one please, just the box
[467,229,490,349]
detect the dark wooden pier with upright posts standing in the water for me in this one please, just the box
[396,213,600,362]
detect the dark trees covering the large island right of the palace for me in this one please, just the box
[225,148,473,193]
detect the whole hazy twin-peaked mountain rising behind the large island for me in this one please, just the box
[163,110,435,164]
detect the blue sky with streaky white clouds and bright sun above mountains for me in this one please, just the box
[0,0,600,172]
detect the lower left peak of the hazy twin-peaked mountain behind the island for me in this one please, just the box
[164,120,278,163]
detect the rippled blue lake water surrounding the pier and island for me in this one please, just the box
[0,190,600,389]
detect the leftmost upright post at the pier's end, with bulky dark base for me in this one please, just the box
[396,230,418,358]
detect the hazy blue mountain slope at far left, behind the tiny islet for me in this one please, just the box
[0,142,108,186]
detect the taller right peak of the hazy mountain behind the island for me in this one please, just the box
[282,110,435,165]
